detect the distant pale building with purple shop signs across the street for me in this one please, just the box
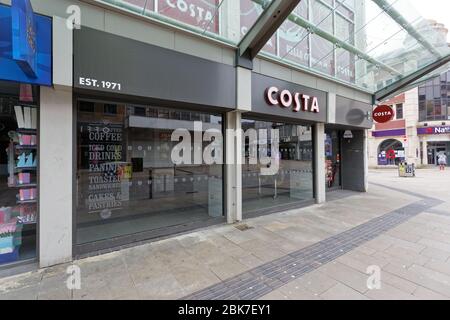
[369,72,450,167]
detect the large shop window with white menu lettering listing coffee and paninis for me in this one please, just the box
[76,101,224,245]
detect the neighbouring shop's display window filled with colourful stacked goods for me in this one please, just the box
[0,82,38,267]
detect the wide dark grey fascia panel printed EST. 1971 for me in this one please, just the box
[74,27,236,109]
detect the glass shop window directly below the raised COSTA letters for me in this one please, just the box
[242,119,314,215]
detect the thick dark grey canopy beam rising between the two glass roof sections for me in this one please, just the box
[238,0,301,60]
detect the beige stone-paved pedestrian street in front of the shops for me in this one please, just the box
[0,169,450,299]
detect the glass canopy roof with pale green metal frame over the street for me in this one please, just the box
[99,0,450,94]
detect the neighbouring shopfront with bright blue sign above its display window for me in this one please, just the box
[0,1,52,267]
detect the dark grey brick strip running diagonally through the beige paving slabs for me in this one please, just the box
[183,197,443,300]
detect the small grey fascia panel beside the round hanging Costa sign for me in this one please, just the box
[336,96,373,129]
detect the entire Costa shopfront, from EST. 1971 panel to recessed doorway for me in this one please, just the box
[70,27,371,256]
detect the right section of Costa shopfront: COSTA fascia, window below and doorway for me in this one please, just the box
[242,73,372,218]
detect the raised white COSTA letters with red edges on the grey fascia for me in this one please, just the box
[265,87,320,113]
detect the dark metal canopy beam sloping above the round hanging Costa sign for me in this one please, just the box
[374,55,450,102]
